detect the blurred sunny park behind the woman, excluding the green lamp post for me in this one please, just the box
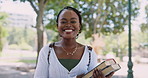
[0,0,148,78]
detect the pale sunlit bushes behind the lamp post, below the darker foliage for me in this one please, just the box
[103,28,148,59]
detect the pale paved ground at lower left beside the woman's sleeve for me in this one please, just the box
[0,62,34,78]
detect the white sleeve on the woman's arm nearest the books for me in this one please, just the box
[88,50,98,71]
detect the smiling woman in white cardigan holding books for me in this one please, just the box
[34,6,113,78]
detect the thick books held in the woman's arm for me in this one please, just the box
[82,59,121,78]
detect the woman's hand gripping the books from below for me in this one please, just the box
[93,69,114,78]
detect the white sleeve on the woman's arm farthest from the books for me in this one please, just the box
[34,46,49,78]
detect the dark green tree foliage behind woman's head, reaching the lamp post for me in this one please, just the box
[46,0,139,38]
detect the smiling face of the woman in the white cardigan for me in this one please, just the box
[58,9,80,39]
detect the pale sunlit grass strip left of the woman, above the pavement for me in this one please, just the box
[0,50,37,63]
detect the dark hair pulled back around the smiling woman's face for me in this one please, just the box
[56,6,82,33]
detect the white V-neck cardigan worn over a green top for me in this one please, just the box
[34,45,97,78]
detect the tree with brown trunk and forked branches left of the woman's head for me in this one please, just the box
[13,0,76,54]
